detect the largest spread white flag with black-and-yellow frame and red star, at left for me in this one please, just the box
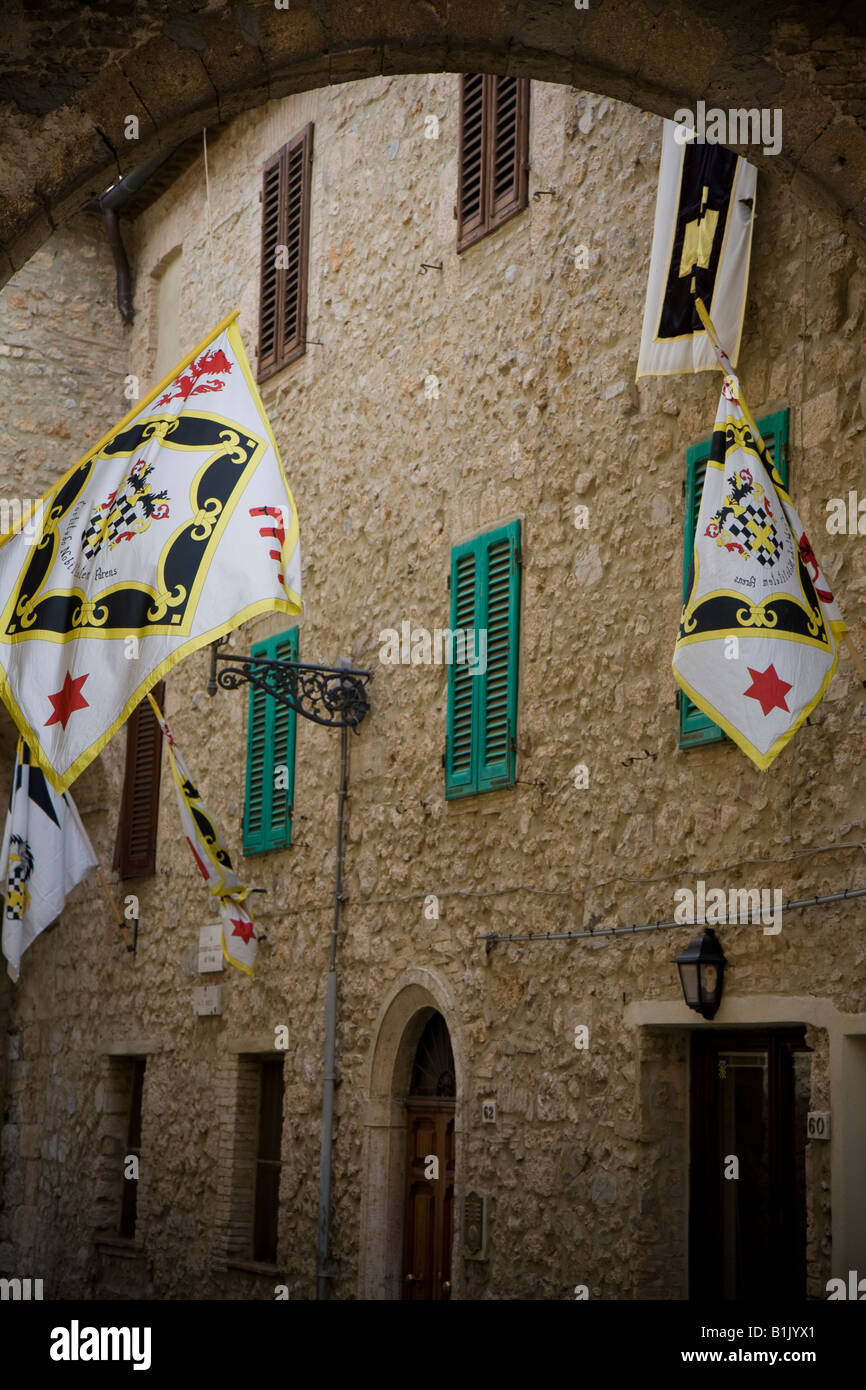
[0,314,300,791]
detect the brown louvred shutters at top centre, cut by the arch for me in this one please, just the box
[457,72,530,252]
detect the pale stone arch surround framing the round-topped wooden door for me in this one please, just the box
[357,967,467,1300]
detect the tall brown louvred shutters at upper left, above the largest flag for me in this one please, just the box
[259,122,313,381]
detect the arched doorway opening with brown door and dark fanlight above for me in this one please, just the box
[402,1012,457,1302]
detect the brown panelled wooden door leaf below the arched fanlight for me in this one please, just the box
[403,1098,455,1302]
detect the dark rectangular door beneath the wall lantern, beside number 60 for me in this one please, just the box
[689,1027,809,1300]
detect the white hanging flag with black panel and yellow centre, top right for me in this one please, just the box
[637,121,758,378]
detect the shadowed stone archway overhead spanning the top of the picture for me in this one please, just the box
[0,0,866,284]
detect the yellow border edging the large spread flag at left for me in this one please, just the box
[0,309,302,795]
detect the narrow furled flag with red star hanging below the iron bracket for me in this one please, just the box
[147,695,259,974]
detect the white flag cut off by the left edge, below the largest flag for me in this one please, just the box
[0,738,97,980]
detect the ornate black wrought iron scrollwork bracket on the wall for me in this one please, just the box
[207,642,373,734]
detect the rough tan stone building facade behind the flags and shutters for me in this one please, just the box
[0,74,866,1300]
